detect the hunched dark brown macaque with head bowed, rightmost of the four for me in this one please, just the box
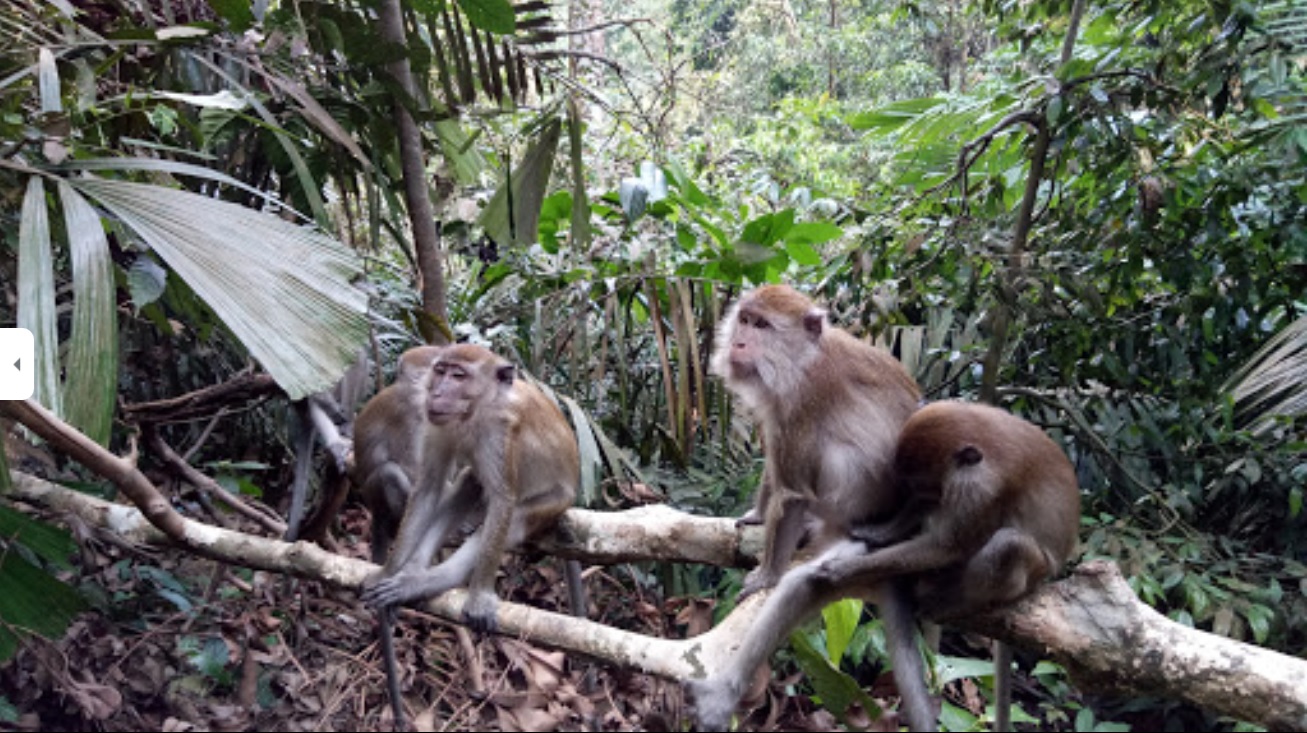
[691,402,1080,730]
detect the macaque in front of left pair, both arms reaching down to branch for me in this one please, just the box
[362,344,580,631]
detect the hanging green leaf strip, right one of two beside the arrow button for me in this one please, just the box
[59,180,118,446]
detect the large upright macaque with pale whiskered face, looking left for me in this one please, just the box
[690,285,933,730]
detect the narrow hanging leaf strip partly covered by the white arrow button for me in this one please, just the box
[17,176,64,415]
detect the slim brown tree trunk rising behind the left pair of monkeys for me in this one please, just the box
[379,0,452,344]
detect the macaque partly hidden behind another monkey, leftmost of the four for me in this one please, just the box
[350,346,440,564]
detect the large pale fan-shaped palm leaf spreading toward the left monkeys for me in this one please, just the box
[69,178,369,400]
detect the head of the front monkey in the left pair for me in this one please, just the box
[426,344,518,425]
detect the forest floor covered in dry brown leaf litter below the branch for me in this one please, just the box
[0,506,878,732]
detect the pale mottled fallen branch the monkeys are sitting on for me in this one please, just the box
[2,472,1307,730]
